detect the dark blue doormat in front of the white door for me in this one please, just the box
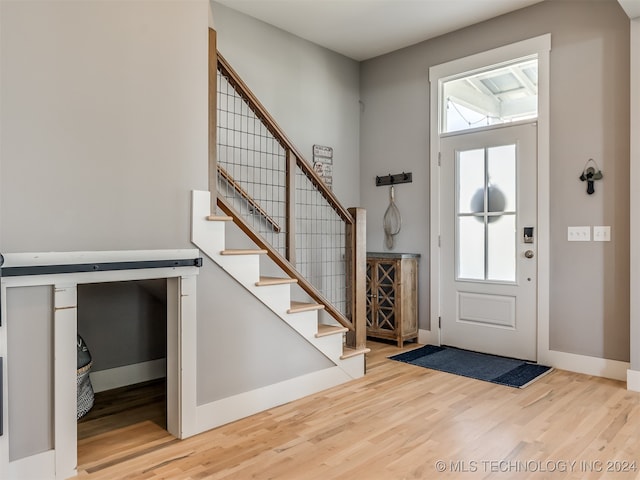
[389,345,552,388]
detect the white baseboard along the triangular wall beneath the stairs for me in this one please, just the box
[192,367,351,438]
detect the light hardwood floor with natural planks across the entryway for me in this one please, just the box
[72,342,640,480]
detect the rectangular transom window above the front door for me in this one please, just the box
[440,56,538,133]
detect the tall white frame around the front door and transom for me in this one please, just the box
[429,33,551,363]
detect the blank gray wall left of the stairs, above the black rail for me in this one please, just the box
[0,0,208,252]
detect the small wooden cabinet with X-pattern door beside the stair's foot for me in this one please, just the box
[367,252,420,347]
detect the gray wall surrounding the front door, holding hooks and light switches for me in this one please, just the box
[360,0,629,361]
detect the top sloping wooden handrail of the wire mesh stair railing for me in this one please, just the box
[217,52,353,224]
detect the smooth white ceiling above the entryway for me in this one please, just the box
[215,0,544,61]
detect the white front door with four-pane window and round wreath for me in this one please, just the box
[440,123,537,360]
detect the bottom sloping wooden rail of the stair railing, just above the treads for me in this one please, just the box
[218,195,355,330]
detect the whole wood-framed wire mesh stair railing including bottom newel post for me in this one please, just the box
[216,53,366,348]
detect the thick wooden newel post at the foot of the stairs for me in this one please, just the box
[346,208,367,350]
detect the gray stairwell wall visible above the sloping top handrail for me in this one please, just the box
[211,2,360,207]
